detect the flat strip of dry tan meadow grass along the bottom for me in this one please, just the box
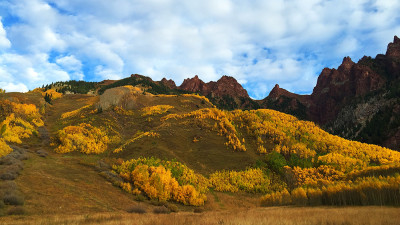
[2,207,400,225]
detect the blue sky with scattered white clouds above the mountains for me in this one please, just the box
[0,0,400,99]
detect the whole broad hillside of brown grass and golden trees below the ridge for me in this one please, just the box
[0,86,400,215]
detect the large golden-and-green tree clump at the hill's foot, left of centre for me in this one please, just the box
[113,158,208,206]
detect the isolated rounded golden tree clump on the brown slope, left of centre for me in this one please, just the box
[53,123,109,154]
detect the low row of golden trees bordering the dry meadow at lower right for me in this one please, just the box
[261,174,400,206]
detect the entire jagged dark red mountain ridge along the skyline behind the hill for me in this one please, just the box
[32,36,400,149]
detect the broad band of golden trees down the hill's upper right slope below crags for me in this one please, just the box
[228,109,400,166]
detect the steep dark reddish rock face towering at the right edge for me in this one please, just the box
[261,36,400,150]
